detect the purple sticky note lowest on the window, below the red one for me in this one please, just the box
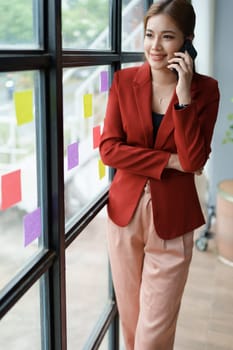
[23,208,41,247]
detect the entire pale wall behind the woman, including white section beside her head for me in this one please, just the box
[192,0,233,205]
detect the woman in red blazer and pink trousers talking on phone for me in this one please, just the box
[100,0,219,350]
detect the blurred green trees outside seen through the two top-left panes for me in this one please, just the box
[0,0,109,48]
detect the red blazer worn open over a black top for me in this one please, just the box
[100,63,219,239]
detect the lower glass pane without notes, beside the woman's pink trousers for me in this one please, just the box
[66,211,108,350]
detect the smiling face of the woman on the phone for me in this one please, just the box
[144,14,184,70]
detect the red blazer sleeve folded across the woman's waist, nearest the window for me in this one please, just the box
[99,73,170,179]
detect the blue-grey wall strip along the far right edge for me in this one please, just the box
[211,0,233,199]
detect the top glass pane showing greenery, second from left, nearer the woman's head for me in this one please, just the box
[62,0,110,50]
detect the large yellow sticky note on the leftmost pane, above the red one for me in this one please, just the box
[14,90,33,125]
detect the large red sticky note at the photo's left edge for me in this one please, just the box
[1,170,21,210]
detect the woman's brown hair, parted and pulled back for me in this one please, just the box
[144,0,196,37]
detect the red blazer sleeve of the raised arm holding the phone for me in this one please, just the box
[173,78,220,172]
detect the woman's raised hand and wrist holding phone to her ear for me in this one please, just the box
[167,51,193,104]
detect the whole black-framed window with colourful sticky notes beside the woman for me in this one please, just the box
[0,0,152,350]
